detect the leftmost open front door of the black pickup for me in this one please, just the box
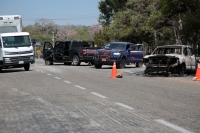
[43,42,53,60]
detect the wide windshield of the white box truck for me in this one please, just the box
[3,36,31,48]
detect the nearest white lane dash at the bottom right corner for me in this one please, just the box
[155,119,192,133]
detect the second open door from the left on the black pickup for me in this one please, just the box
[53,42,65,61]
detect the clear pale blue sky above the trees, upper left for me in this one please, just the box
[0,0,101,26]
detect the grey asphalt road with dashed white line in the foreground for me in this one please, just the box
[0,59,200,133]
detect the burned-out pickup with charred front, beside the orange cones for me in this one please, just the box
[143,45,196,76]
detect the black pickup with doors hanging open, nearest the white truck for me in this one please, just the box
[43,40,98,66]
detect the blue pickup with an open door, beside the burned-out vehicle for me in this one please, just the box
[94,42,145,69]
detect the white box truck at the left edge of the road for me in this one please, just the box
[0,15,35,72]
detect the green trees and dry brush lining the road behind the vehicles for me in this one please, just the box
[24,0,200,53]
